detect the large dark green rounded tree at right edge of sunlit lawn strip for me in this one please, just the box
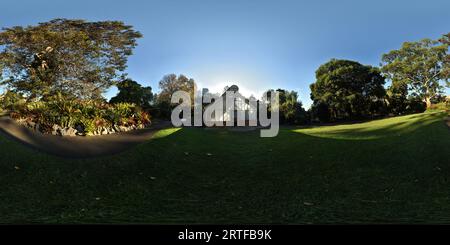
[310,59,385,120]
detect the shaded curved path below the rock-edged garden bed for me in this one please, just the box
[0,116,172,158]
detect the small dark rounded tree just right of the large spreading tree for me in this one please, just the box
[109,79,154,108]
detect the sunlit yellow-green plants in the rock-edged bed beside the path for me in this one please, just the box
[8,94,151,135]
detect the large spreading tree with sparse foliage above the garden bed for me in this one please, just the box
[0,19,142,99]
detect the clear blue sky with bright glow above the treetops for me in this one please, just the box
[0,0,450,108]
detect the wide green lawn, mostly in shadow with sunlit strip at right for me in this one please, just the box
[0,113,450,223]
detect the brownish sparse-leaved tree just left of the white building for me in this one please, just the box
[156,74,197,118]
